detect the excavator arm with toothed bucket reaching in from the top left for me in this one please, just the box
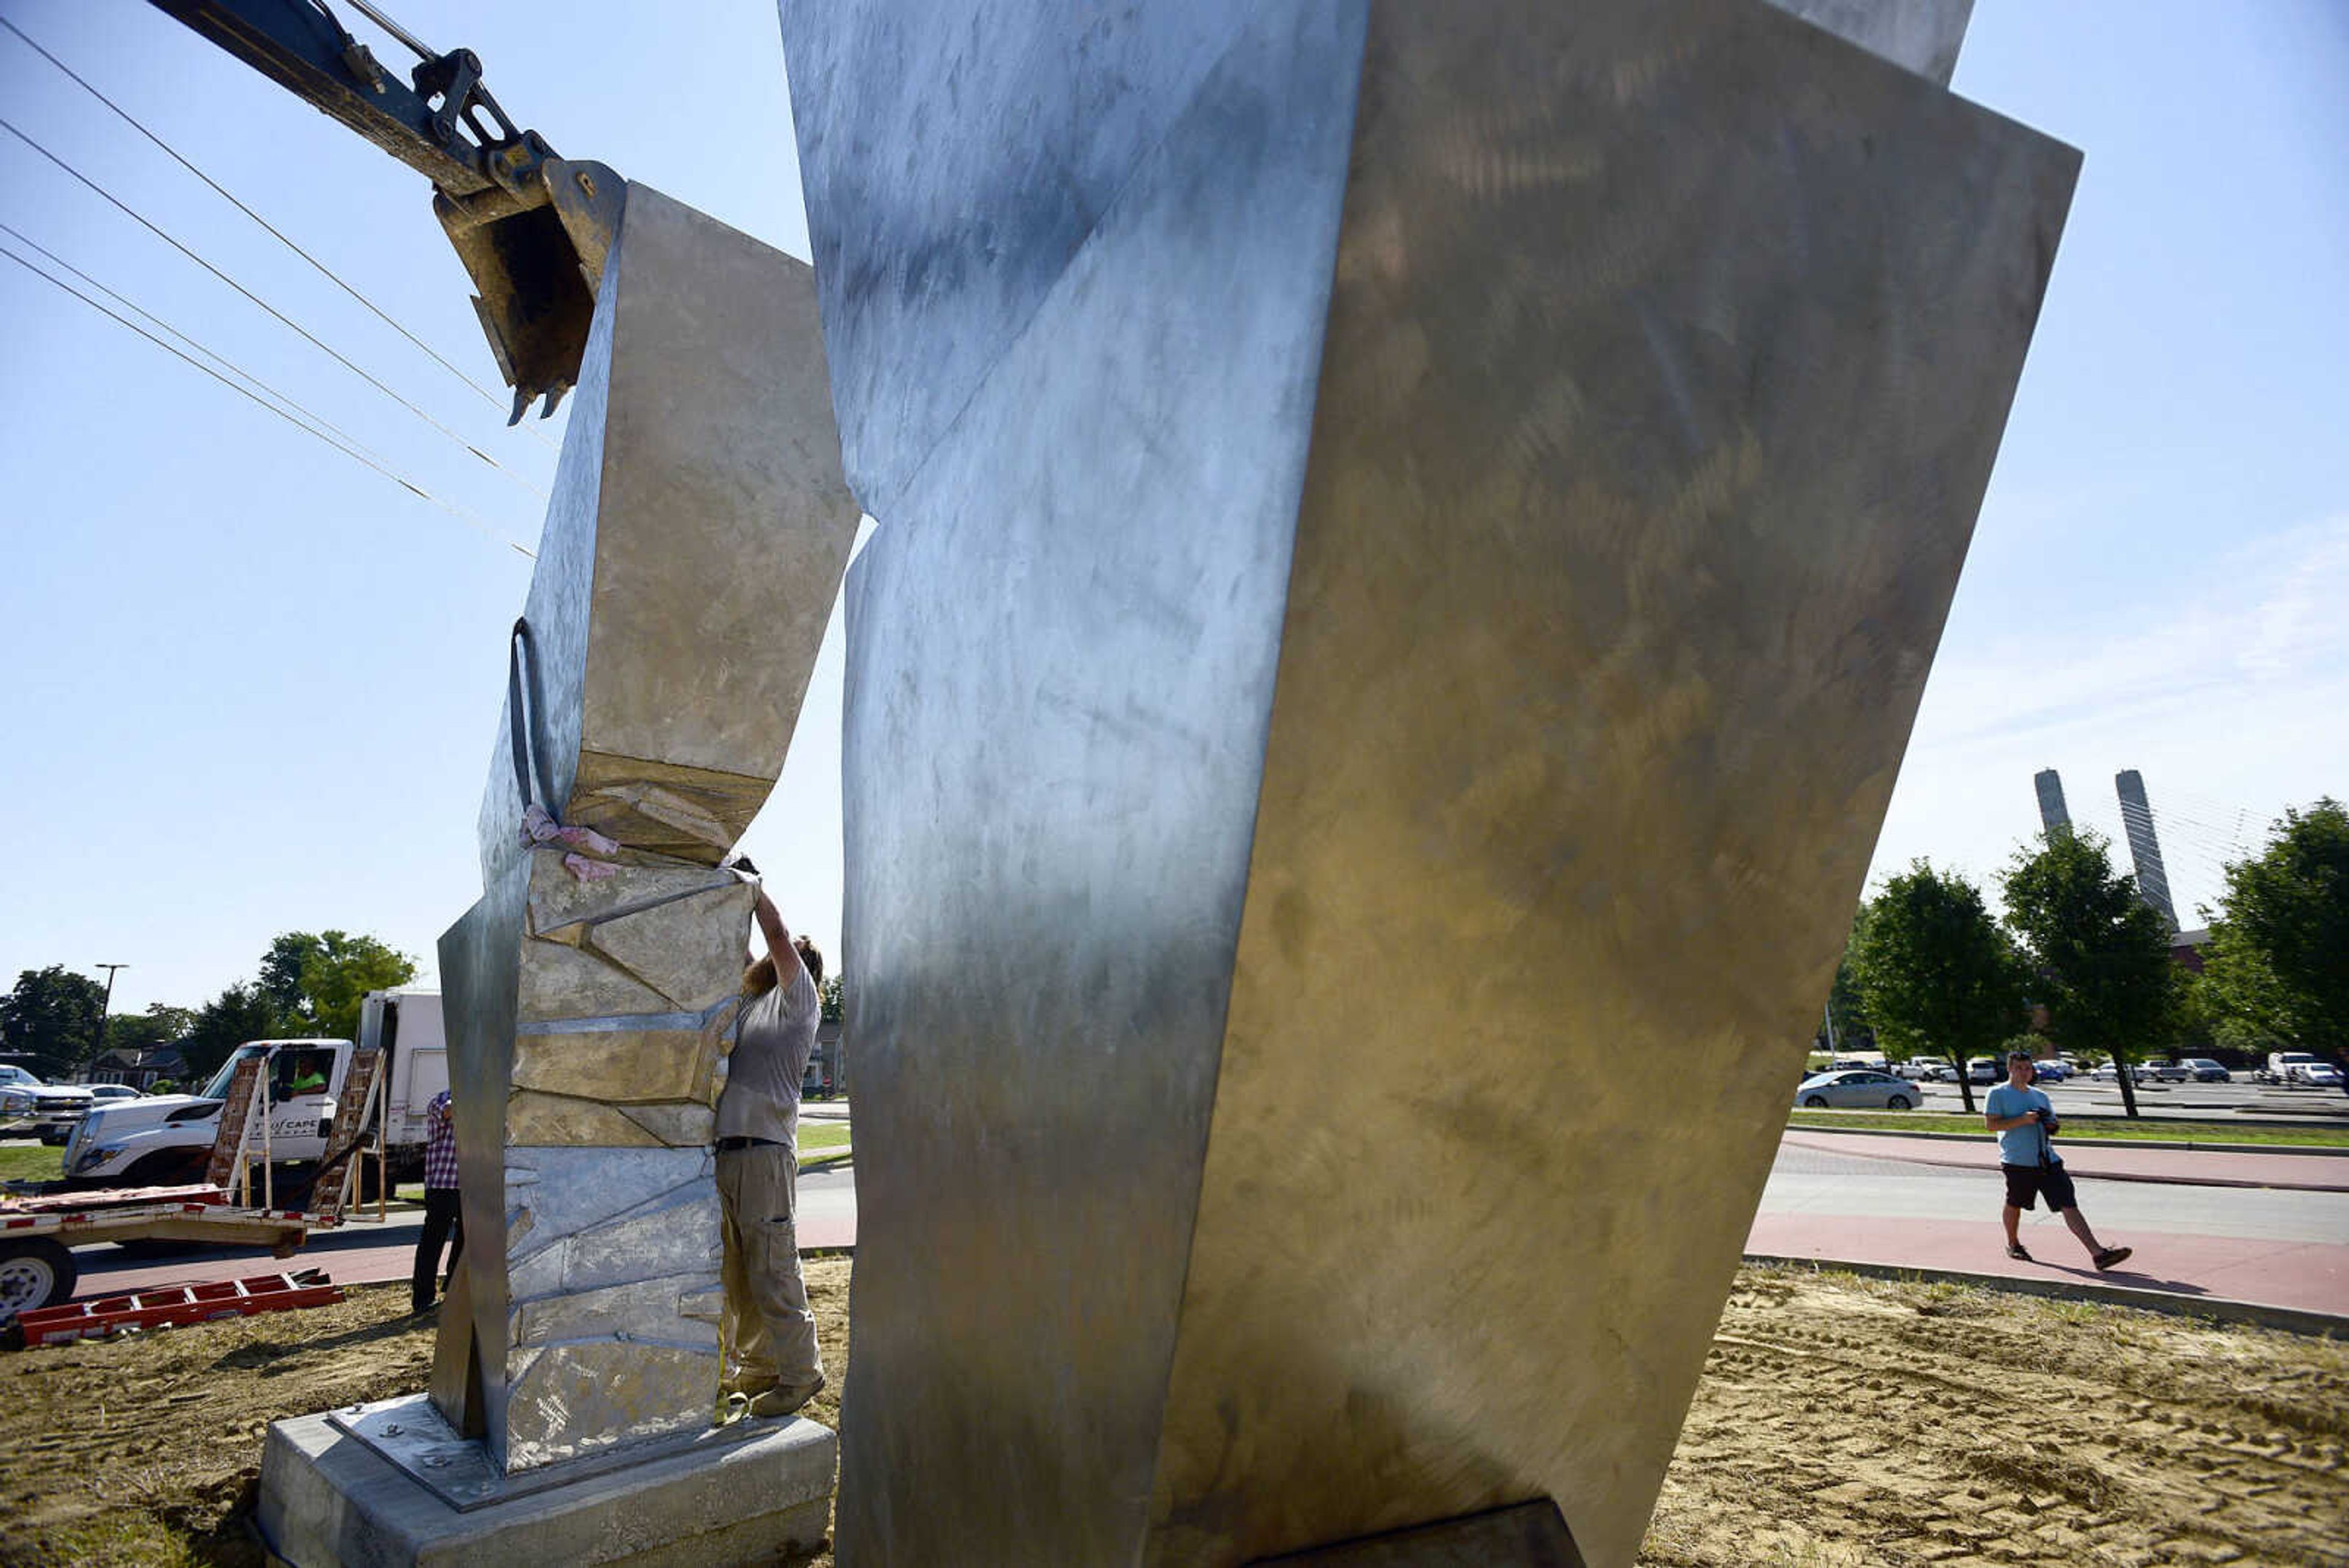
[150,0,627,423]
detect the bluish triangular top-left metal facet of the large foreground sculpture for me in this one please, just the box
[780,0,1259,517]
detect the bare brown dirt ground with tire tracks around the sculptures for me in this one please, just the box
[0,1260,2349,1568]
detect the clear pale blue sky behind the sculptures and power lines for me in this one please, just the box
[0,0,2349,1008]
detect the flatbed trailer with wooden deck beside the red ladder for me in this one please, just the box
[0,1187,343,1326]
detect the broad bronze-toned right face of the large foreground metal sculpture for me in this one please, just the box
[1146,0,2079,1568]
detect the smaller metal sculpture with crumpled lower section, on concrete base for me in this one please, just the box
[434,186,858,1474]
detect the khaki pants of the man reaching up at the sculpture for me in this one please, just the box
[719,1145,825,1394]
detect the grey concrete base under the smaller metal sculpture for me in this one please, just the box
[256,1413,839,1568]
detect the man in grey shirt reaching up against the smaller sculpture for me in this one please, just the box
[716,865,825,1418]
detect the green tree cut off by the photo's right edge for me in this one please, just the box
[2201,797,2349,1053]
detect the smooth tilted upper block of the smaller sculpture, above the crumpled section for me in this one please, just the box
[479,186,858,879]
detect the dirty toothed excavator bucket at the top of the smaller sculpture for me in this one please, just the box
[432,157,627,423]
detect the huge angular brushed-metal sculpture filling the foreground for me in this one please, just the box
[782,0,2077,1568]
